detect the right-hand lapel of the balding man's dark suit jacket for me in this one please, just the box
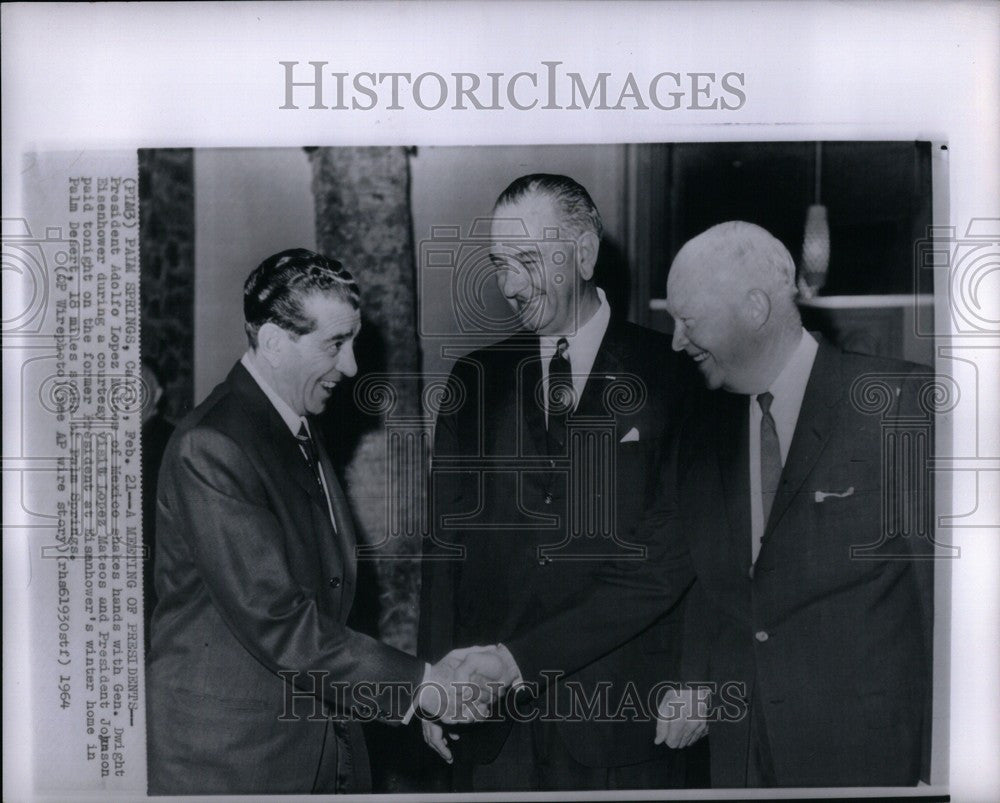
[764,342,844,538]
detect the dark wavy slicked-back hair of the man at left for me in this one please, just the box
[243,248,361,349]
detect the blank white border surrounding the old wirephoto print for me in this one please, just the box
[2,2,1000,801]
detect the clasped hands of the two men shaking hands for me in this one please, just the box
[414,644,521,764]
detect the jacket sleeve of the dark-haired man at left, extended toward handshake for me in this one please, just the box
[160,427,423,718]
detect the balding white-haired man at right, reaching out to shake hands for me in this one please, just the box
[463,222,933,786]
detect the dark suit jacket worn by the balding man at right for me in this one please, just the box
[508,344,933,786]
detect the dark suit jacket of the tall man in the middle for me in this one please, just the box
[419,320,698,767]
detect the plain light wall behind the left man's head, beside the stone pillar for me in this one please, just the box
[194,148,316,404]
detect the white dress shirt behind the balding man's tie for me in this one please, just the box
[750,329,819,563]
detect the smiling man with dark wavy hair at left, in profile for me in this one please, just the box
[146,249,484,794]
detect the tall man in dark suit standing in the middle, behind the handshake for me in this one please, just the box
[420,174,706,791]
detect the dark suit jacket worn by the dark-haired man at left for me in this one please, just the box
[146,363,423,794]
